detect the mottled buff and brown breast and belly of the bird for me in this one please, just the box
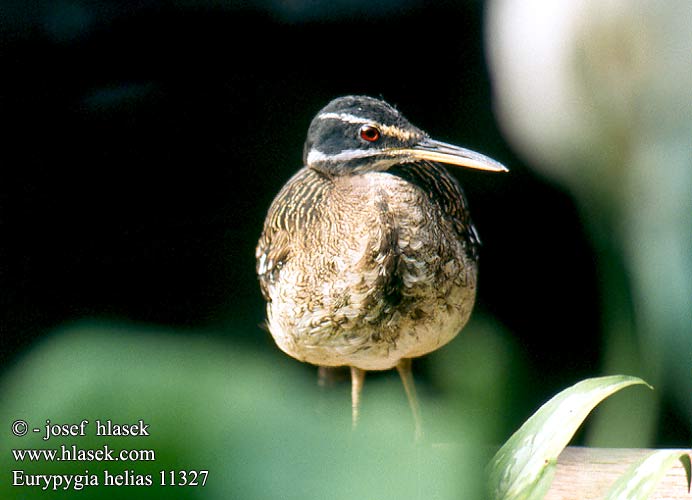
[268,172,476,369]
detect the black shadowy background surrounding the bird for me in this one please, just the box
[0,1,679,442]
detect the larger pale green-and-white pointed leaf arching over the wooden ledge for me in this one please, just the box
[490,375,646,500]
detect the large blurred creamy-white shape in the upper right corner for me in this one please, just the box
[486,0,692,193]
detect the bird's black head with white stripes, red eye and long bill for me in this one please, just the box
[303,96,507,176]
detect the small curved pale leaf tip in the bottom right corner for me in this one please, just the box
[604,450,692,500]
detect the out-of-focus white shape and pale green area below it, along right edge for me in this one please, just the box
[486,0,692,438]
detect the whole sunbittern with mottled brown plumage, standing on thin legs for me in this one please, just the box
[255,95,507,437]
